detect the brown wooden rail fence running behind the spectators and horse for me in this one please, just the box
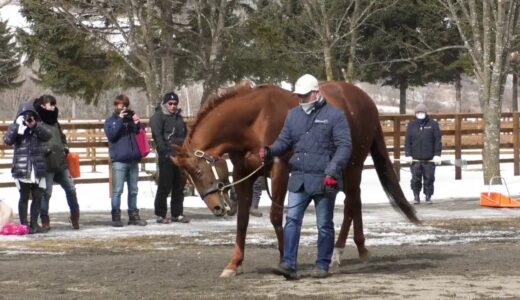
[0,113,520,187]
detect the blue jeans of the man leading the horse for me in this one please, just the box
[282,192,336,271]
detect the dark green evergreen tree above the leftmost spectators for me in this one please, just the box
[18,1,131,103]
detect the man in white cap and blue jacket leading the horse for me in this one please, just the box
[259,74,352,279]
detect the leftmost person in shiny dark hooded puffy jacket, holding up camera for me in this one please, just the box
[4,101,51,234]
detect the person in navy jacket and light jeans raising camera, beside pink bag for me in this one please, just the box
[104,95,147,227]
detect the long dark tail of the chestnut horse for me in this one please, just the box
[370,126,421,224]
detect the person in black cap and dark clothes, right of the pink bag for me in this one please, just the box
[150,92,190,224]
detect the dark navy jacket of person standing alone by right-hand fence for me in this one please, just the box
[404,117,442,160]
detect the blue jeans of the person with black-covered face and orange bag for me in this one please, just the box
[40,169,79,217]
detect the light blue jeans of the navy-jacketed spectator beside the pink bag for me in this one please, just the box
[112,161,139,211]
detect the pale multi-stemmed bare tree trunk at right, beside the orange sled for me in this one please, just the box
[438,0,520,183]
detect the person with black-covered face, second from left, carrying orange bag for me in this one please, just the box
[34,95,79,230]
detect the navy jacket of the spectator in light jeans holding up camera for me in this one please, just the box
[104,113,141,163]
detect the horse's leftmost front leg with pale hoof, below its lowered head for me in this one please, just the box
[220,180,252,278]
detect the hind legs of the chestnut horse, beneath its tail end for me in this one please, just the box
[331,169,370,265]
